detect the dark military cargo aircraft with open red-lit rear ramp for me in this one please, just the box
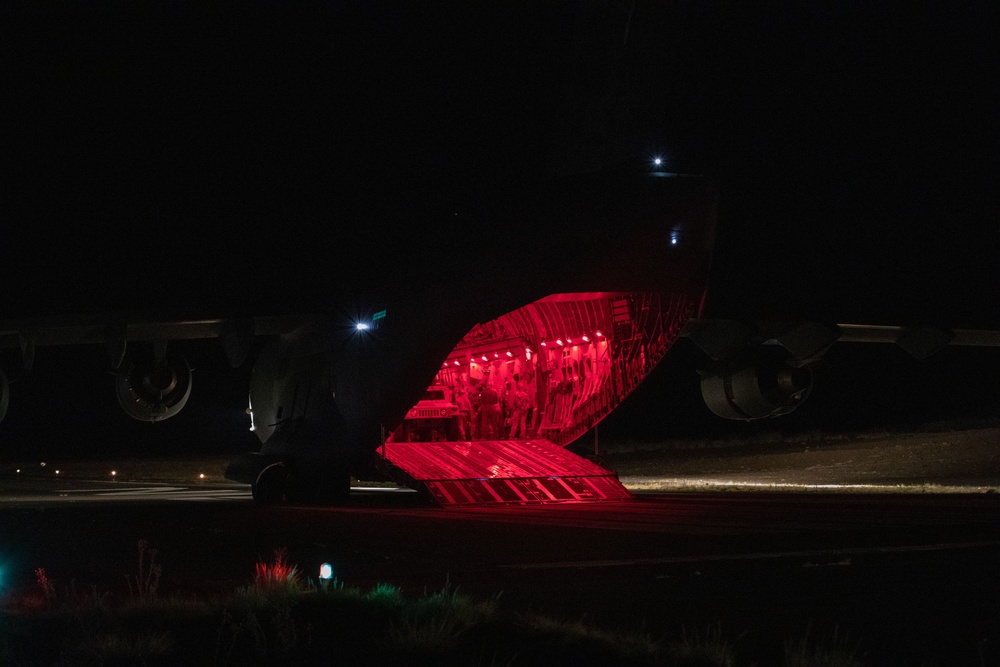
[0,162,1000,504]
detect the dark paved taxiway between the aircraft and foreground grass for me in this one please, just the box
[0,480,1000,664]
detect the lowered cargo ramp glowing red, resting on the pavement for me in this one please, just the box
[381,438,633,507]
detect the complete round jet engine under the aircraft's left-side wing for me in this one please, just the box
[115,351,191,422]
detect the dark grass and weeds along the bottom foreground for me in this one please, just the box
[0,541,884,667]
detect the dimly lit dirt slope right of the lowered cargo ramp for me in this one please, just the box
[601,427,1000,492]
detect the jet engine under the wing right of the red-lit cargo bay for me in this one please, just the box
[701,357,813,421]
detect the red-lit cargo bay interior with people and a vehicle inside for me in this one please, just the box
[387,292,698,446]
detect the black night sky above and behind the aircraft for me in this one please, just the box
[0,2,1000,456]
